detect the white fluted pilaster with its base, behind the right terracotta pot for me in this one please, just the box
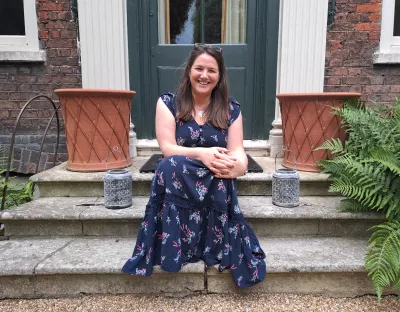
[269,0,328,157]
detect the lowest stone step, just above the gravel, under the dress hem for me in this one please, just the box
[0,237,382,299]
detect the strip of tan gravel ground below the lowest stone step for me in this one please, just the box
[0,294,400,312]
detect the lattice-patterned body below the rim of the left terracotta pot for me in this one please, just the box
[60,95,131,163]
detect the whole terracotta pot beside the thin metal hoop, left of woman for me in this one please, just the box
[54,89,136,172]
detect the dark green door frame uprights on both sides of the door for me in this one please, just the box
[127,0,280,140]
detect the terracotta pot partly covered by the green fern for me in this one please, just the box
[276,92,361,172]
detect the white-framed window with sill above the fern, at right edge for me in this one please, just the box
[374,0,400,64]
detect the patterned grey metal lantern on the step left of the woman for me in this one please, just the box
[104,169,132,209]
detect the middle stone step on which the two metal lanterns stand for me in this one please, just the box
[0,196,384,237]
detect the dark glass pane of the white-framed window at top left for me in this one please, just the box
[0,0,25,36]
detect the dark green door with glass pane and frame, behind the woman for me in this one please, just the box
[128,0,279,139]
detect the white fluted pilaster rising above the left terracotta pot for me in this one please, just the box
[78,0,129,90]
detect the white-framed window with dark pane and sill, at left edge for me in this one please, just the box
[0,0,44,61]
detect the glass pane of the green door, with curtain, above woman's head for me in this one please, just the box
[158,0,247,44]
